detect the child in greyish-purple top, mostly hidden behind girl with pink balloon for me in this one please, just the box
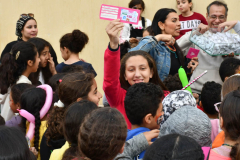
[5,83,34,132]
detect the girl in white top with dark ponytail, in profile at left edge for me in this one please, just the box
[0,42,40,121]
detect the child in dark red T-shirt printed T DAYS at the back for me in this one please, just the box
[175,0,208,40]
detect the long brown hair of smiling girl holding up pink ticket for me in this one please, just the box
[120,50,168,90]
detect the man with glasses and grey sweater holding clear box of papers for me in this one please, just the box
[177,1,240,94]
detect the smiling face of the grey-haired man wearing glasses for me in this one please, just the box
[206,5,227,28]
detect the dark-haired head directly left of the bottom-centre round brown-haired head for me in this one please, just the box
[63,100,97,160]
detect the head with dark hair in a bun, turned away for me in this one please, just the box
[60,29,88,61]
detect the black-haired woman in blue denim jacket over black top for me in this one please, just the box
[130,8,184,81]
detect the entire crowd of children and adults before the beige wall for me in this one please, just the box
[0,0,240,160]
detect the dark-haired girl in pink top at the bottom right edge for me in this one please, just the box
[209,90,240,160]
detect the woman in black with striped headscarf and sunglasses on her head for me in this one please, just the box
[1,13,58,65]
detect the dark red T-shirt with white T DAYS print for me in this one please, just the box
[175,12,208,40]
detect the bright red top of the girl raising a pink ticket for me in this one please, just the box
[103,48,169,129]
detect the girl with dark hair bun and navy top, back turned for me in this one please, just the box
[56,29,97,76]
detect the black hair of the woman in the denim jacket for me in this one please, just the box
[152,8,185,66]
